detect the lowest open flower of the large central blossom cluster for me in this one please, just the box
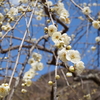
[75,61,85,75]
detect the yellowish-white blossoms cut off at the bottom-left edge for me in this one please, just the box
[0,83,10,98]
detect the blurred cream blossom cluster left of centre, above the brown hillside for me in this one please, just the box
[22,52,44,86]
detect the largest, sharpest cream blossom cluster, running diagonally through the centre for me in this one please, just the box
[47,22,85,75]
